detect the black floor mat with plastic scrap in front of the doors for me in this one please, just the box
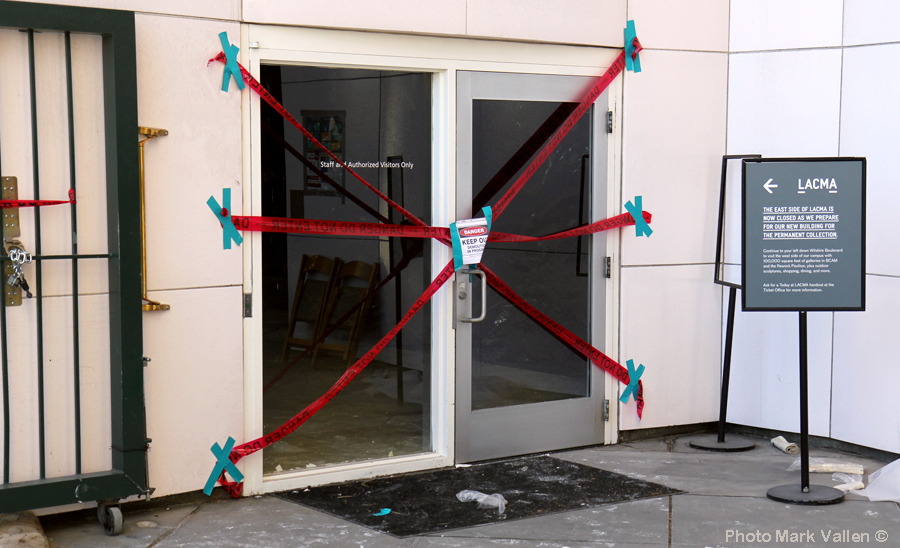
[275,456,681,537]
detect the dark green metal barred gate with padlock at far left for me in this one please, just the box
[0,1,149,513]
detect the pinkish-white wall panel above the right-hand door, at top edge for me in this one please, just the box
[466,0,624,48]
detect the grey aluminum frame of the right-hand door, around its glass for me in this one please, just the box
[453,71,609,462]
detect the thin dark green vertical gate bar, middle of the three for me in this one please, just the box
[28,29,47,479]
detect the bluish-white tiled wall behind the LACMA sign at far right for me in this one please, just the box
[722,0,900,452]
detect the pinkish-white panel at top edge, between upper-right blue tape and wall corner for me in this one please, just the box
[628,0,729,52]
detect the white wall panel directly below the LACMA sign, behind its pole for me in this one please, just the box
[721,296,832,436]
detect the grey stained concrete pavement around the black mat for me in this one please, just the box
[37,437,900,548]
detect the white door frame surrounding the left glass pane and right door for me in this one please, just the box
[240,24,622,495]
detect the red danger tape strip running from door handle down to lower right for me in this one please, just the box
[478,264,644,418]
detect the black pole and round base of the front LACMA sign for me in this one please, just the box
[766,310,844,505]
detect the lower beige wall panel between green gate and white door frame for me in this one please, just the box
[144,287,244,496]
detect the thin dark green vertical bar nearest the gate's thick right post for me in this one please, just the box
[66,31,81,474]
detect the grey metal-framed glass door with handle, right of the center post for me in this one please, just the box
[453,72,607,462]
